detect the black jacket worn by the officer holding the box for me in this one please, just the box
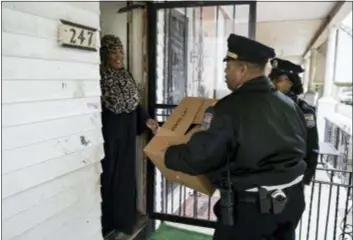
[165,77,307,190]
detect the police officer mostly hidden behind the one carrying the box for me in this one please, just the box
[269,58,319,185]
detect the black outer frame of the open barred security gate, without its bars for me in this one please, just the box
[147,1,256,228]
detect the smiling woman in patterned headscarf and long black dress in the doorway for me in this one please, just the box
[100,35,158,239]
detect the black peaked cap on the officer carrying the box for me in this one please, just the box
[223,34,276,63]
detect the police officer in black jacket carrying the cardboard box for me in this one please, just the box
[165,34,306,240]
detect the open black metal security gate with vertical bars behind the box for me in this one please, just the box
[147,1,256,227]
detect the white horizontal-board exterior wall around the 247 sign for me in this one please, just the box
[2,2,103,240]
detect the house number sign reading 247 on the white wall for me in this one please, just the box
[58,20,98,51]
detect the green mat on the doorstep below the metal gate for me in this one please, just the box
[148,224,212,240]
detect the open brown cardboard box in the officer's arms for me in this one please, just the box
[144,97,217,196]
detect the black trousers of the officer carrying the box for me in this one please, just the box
[213,183,305,240]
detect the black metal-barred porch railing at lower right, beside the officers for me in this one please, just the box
[297,167,352,240]
